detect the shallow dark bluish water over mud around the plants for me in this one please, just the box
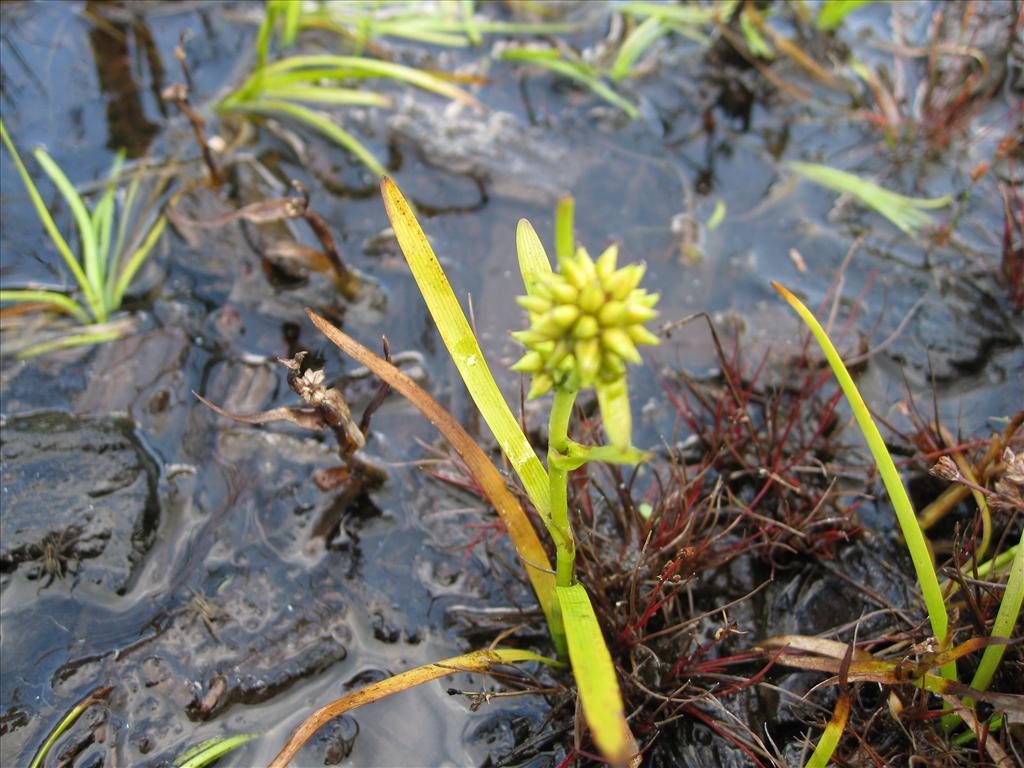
[0,2,1024,766]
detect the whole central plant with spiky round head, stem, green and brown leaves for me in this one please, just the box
[273,177,657,768]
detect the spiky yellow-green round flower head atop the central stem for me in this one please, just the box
[512,246,658,398]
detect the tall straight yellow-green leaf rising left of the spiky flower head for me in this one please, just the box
[381,176,551,519]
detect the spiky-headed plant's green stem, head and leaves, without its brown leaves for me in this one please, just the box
[381,178,657,763]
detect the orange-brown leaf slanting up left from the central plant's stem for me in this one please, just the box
[306,310,561,643]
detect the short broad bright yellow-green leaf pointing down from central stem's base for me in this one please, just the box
[555,584,640,766]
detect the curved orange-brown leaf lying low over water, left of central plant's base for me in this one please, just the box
[269,648,558,768]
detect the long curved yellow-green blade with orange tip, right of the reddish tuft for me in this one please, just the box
[772,282,956,680]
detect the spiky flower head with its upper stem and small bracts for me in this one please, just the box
[512,201,657,587]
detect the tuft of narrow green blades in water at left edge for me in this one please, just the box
[0,120,167,354]
